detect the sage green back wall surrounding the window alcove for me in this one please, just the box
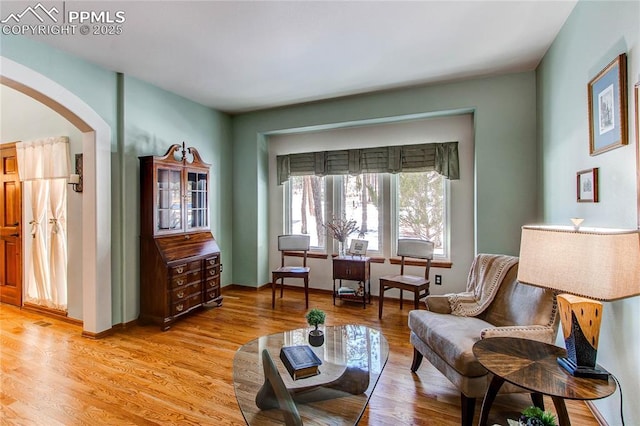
[233,72,537,286]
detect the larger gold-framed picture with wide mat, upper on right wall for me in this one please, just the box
[587,53,628,155]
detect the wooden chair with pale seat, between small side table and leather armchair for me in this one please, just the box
[378,238,433,318]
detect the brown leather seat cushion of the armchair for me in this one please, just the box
[409,310,493,377]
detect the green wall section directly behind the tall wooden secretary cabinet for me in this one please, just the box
[121,77,232,318]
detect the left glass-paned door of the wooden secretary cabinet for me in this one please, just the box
[156,168,183,232]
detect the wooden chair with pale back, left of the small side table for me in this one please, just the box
[271,235,310,309]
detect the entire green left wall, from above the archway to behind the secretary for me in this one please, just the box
[0,36,232,324]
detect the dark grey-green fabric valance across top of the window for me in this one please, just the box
[276,142,460,185]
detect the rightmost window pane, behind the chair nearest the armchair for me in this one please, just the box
[395,172,447,256]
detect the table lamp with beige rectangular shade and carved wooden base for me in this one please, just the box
[518,226,640,379]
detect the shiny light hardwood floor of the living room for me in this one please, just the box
[0,287,598,426]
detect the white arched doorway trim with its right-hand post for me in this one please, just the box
[0,57,112,337]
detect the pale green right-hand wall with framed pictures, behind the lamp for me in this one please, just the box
[536,1,640,425]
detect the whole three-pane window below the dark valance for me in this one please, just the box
[284,172,448,257]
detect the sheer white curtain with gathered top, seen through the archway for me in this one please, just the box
[16,136,69,309]
